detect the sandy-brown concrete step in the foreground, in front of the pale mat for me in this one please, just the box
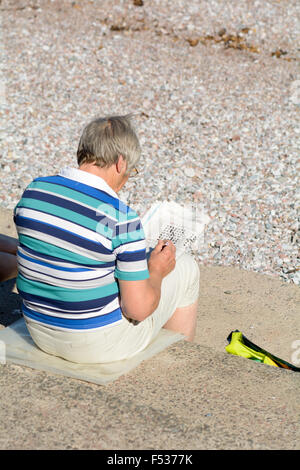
[0,341,300,450]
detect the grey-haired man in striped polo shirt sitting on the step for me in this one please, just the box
[14,116,199,363]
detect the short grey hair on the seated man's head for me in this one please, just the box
[77,114,141,171]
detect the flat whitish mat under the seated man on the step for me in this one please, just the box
[0,318,184,385]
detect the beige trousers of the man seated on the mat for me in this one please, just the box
[26,254,200,363]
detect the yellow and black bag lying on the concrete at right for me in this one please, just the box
[225,330,300,372]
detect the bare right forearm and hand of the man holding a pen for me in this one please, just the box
[118,240,176,321]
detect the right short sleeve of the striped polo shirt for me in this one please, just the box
[112,209,149,281]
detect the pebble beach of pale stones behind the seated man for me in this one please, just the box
[0,0,300,285]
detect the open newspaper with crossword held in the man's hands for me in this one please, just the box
[142,201,210,259]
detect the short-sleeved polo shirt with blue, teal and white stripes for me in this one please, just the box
[14,168,149,331]
